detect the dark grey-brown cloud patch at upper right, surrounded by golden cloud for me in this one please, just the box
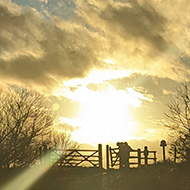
[100,0,168,51]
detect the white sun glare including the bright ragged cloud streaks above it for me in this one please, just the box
[54,71,148,145]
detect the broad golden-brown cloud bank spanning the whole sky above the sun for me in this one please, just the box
[0,0,190,89]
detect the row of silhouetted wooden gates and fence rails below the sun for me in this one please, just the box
[40,144,157,169]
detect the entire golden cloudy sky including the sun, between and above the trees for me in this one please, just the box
[0,0,190,151]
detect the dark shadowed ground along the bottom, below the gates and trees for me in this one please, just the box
[0,163,190,190]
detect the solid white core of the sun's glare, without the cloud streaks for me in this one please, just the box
[68,86,141,144]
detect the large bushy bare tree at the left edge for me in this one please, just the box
[0,89,53,168]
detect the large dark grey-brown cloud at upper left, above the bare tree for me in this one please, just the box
[0,1,96,83]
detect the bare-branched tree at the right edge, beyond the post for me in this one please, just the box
[165,83,190,161]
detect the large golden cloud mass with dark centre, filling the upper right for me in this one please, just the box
[76,0,190,81]
